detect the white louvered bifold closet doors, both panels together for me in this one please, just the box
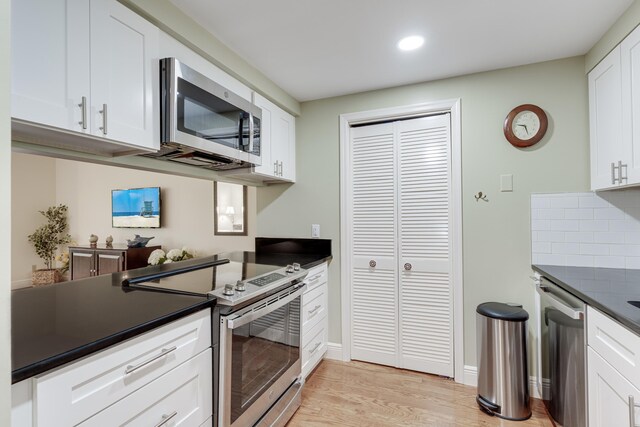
[348,114,454,377]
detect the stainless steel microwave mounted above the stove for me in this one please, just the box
[149,58,262,170]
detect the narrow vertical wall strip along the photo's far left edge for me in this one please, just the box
[0,1,11,426]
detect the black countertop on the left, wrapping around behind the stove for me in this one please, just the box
[11,238,332,383]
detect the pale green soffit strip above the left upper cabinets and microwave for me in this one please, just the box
[118,0,300,116]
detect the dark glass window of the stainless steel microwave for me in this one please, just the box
[177,79,244,149]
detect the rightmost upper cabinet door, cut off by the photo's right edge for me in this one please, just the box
[620,25,640,184]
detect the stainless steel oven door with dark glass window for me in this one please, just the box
[219,287,303,426]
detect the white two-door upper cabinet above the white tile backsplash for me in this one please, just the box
[589,23,640,190]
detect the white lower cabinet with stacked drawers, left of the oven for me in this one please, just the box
[12,309,213,427]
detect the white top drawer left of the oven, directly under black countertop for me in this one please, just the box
[35,309,211,427]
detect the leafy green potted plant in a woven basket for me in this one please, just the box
[27,205,71,286]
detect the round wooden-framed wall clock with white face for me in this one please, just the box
[503,104,549,147]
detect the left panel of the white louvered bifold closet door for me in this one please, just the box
[350,123,398,366]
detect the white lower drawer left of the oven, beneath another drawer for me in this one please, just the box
[81,349,213,427]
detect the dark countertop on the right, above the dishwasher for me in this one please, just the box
[532,265,640,335]
